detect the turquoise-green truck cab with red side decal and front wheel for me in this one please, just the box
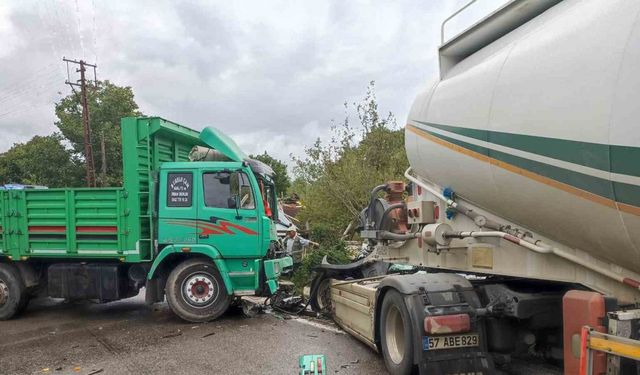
[143,128,292,321]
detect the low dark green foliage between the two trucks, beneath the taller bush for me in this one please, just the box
[291,225,351,294]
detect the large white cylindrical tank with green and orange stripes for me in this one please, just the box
[405,0,640,272]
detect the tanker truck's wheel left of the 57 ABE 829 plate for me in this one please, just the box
[380,290,414,375]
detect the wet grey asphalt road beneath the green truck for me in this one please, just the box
[0,296,387,375]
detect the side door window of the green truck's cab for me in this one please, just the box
[202,172,256,210]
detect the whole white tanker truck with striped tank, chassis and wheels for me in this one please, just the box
[312,0,640,374]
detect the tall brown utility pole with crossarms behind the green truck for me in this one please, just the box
[62,57,97,187]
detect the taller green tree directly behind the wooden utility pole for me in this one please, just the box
[55,81,142,186]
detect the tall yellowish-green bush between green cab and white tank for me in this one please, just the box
[294,82,409,237]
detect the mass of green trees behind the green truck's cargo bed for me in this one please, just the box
[0,81,142,187]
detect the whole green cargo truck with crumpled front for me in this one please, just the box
[0,117,292,322]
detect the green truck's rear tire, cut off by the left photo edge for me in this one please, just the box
[0,263,28,320]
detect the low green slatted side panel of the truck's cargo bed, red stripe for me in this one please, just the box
[0,188,127,260]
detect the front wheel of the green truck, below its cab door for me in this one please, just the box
[165,258,233,323]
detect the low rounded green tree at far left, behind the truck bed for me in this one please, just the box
[0,133,84,187]
